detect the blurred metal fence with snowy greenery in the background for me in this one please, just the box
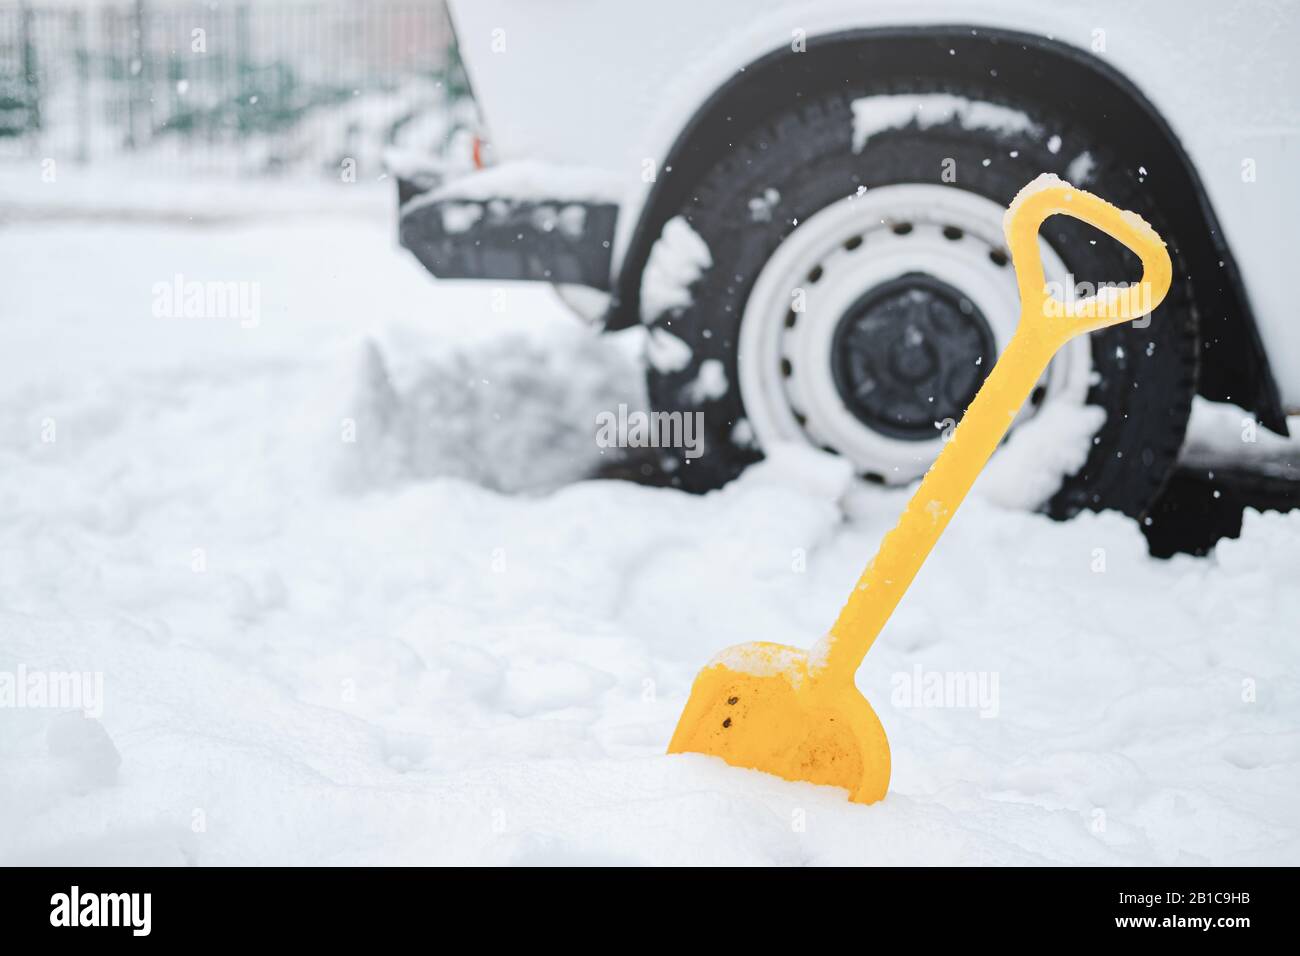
[0,0,465,172]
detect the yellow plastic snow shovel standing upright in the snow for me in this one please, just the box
[668,176,1173,804]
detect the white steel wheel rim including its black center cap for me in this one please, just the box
[737,183,1092,484]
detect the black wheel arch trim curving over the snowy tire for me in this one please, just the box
[607,26,1286,434]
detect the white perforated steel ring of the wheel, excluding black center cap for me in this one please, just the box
[737,183,1092,484]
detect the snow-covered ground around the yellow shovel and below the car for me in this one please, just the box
[0,170,1300,864]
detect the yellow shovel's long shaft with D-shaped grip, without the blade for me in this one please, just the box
[810,176,1173,683]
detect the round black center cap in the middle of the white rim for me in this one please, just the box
[831,272,997,441]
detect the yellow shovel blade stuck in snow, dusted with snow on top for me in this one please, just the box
[668,643,889,804]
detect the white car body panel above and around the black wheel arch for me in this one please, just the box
[450,0,1300,411]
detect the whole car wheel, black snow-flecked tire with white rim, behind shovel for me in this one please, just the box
[642,85,1197,518]
